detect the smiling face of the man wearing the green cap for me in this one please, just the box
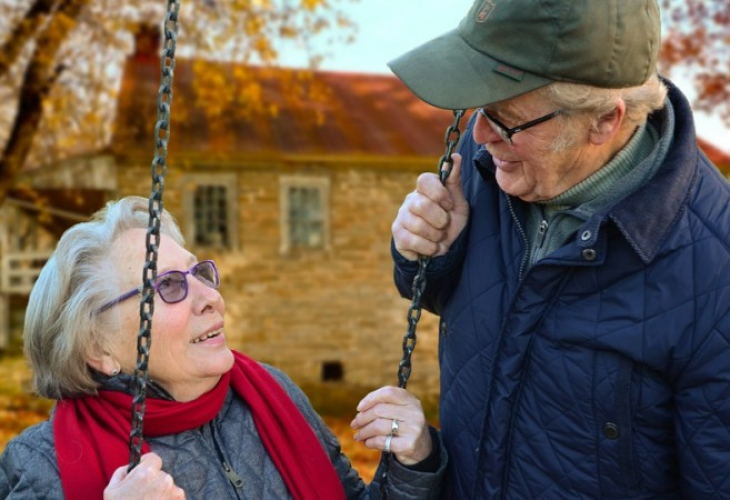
[473,92,602,202]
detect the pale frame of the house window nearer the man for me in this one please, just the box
[279,175,331,254]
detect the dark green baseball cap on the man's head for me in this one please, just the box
[388,0,661,109]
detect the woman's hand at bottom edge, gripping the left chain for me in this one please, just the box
[104,453,185,500]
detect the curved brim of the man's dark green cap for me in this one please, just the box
[388,29,551,109]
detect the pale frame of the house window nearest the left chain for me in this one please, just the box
[181,173,239,251]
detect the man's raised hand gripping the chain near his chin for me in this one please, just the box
[391,154,469,260]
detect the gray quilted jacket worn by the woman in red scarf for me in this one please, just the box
[0,366,446,500]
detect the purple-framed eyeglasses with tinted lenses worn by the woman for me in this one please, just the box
[96,260,221,314]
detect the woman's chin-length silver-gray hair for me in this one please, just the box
[23,196,184,399]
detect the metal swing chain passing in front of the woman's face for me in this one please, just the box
[128,0,180,471]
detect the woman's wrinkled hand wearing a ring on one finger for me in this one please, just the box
[350,387,433,465]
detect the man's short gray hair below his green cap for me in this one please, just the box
[535,73,667,151]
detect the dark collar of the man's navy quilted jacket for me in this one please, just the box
[470,80,699,263]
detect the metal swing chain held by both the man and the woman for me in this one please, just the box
[380,109,465,500]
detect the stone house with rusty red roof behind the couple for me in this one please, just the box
[0,29,453,406]
